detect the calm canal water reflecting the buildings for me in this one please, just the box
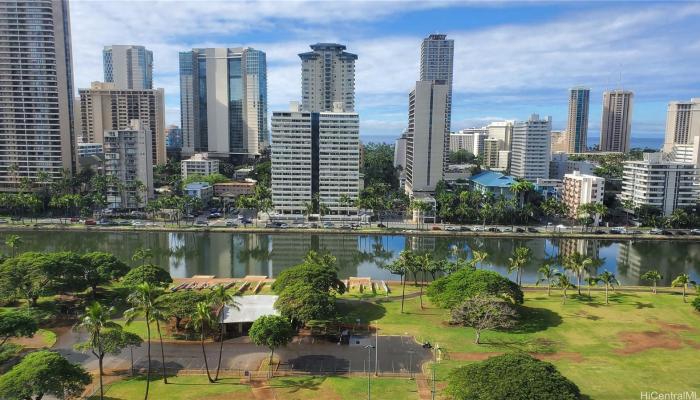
[6,231,700,285]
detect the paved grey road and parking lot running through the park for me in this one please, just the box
[53,324,432,373]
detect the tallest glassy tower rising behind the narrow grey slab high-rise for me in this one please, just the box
[420,34,455,132]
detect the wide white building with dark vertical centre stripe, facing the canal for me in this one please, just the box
[271,102,360,215]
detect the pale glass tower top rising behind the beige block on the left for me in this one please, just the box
[102,45,153,89]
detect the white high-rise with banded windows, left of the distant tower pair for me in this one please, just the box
[510,114,552,181]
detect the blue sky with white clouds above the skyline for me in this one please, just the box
[70,0,700,144]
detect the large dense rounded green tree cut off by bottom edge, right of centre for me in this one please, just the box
[447,353,581,400]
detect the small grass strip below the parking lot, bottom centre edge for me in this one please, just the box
[270,376,418,400]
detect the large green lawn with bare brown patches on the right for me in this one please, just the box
[344,291,700,399]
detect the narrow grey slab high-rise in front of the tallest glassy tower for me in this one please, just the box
[405,81,449,195]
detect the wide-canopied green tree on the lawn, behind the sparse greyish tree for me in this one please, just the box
[427,268,523,309]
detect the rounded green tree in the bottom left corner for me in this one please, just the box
[0,350,92,400]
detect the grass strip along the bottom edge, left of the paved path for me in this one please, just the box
[90,375,254,400]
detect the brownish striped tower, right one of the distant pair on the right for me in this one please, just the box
[600,89,634,153]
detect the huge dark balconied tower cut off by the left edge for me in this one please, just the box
[0,0,76,191]
